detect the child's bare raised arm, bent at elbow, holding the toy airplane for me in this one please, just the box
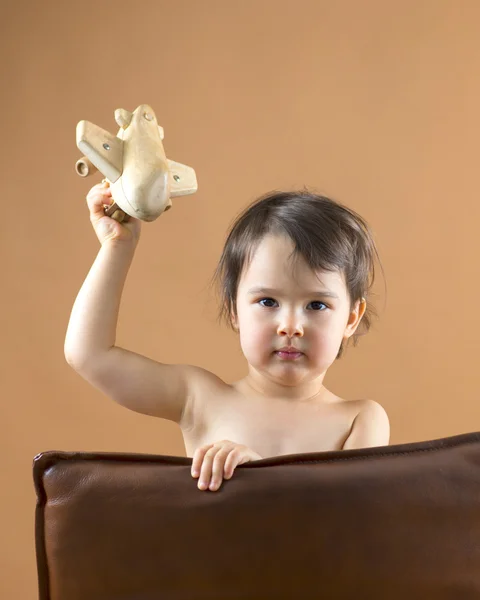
[64,184,203,423]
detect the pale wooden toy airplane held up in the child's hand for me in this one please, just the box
[75,104,198,222]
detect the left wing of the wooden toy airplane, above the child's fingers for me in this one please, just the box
[77,121,123,183]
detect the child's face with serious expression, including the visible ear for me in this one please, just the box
[232,235,365,385]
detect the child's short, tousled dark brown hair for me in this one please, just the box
[212,189,383,359]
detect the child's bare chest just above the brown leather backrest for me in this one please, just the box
[183,384,359,458]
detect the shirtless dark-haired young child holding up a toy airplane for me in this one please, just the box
[65,183,390,491]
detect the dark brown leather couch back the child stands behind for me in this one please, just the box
[34,433,480,600]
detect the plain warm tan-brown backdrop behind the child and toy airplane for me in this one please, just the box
[0,0,480,600]
